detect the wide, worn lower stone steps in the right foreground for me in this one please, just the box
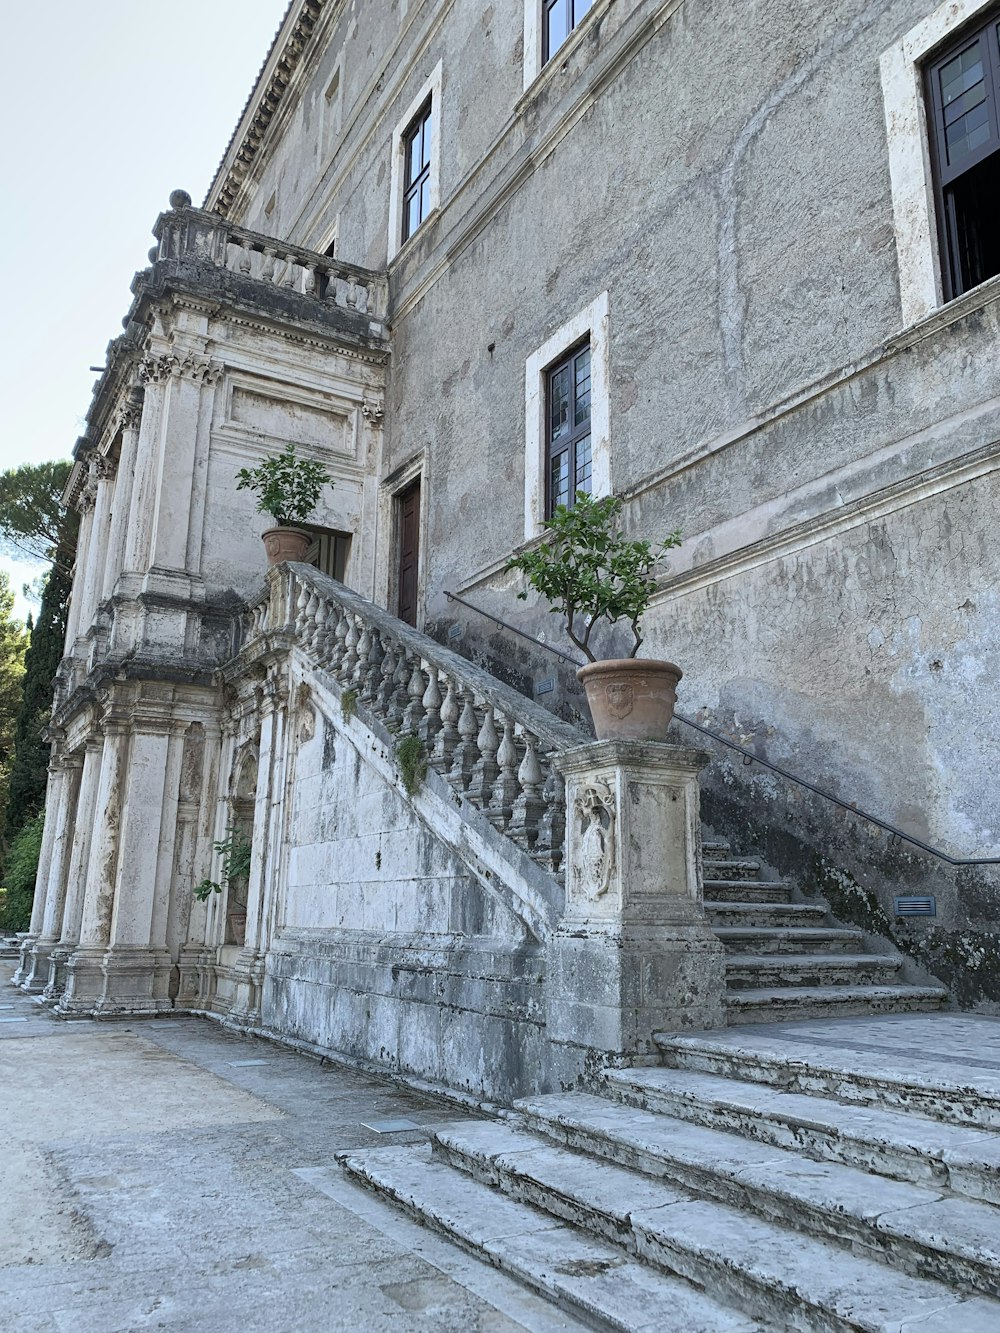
[341,1014,1000,1333]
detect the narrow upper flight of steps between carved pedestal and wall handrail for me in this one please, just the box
[701,837,948,1022]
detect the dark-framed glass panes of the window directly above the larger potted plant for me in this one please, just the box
[545,340,593,517]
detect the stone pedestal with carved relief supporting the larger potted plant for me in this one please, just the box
[547,741,725,1064]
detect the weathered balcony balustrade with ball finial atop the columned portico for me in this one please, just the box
[149,207,388,323]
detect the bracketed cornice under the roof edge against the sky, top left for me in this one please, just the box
[205,0,329,217]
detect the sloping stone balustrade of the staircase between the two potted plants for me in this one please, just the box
[243,564,588,874]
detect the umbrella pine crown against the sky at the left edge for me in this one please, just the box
[0,461,77,575]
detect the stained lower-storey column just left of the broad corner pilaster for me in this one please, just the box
[59,718,131,1013]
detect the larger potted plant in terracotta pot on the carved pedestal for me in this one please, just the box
[505,491,681,741]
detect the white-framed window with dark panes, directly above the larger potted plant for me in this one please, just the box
[524,292,612,541]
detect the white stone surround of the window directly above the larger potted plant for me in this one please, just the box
[524,291,611,541]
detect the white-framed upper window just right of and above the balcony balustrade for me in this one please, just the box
[388,60,444,263]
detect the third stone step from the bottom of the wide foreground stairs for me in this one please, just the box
[516,1093,1000,1297]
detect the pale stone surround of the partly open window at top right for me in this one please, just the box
[879,0,996,325]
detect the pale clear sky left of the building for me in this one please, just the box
[0,0,287,616]
